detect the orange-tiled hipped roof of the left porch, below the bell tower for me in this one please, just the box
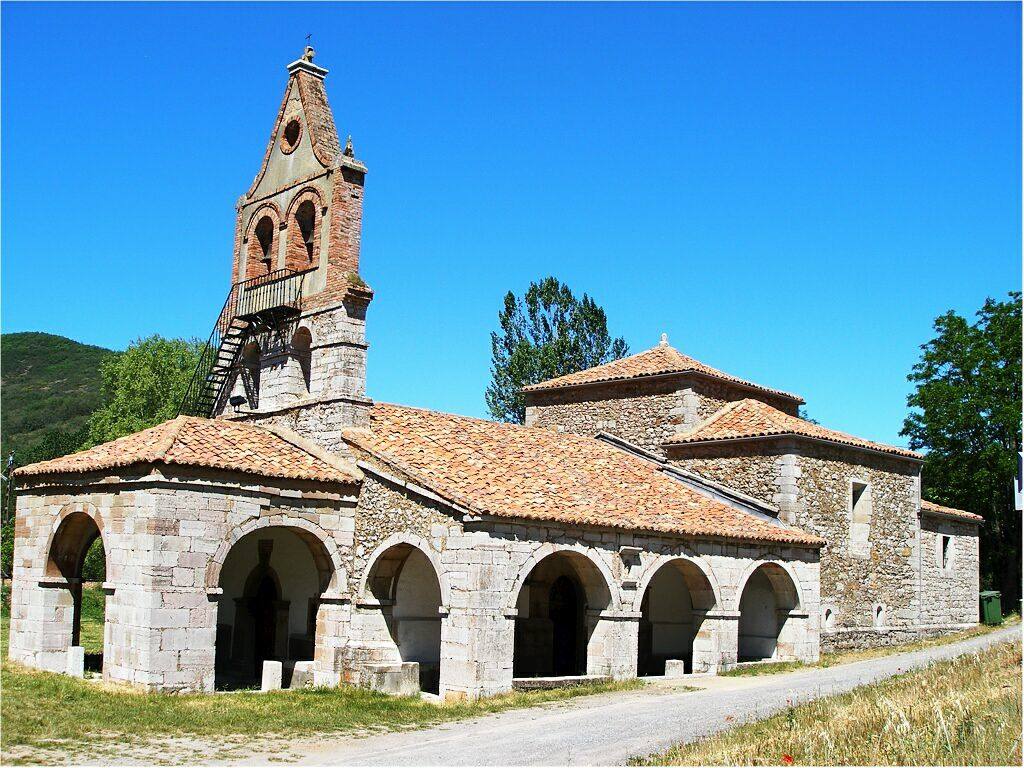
[15,416,359,482]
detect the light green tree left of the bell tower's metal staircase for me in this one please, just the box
[87,336,203,445]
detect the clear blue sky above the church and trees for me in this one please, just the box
[0,3,1021,443]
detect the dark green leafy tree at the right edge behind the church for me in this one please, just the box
[902,292,1022,607]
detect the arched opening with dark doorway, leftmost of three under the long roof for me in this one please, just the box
[512,552,611,678]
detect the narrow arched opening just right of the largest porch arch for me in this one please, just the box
[367,544,441,693]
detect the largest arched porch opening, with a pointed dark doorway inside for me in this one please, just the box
[214,526,333,689]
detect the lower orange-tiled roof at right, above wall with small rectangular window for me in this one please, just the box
[665,399,923,460]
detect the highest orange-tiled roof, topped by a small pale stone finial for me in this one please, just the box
[522,342,804,402]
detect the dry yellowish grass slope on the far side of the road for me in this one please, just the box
[631,642,1021,765]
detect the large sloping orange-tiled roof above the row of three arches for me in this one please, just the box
[344,403,821,546]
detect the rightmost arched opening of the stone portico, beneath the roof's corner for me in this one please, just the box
[738,563,800,662]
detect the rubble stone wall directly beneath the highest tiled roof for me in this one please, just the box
[526,375,798,455]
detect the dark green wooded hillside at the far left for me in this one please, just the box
[0,333,113,457]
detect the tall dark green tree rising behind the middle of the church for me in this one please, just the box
[485,278,630,424]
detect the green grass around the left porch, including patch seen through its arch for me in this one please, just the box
[0,588,643,762]
